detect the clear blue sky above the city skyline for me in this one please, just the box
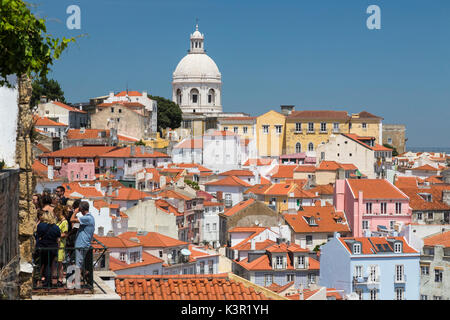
[30,0,450,147]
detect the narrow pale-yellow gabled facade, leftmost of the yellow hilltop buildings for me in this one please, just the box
[256,110,286,157]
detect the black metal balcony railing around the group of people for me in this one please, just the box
[33,239,107,292]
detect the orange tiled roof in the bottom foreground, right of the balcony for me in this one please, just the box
[115,274,269,301]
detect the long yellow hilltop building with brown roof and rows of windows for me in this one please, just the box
[286,110,350,154]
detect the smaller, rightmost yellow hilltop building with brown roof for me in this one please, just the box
[343,111,383,144]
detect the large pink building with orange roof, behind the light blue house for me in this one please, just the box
[334,179,412,237]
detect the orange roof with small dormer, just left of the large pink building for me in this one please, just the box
[283,205,350,233]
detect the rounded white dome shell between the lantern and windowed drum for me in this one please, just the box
[173,53,221,78]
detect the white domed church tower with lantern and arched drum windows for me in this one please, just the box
[172,25,222,113]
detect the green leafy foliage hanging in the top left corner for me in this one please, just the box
[0,0,75,87]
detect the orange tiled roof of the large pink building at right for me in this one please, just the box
[346,179,408,199]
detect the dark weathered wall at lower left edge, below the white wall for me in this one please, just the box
[0,169,19,299]
